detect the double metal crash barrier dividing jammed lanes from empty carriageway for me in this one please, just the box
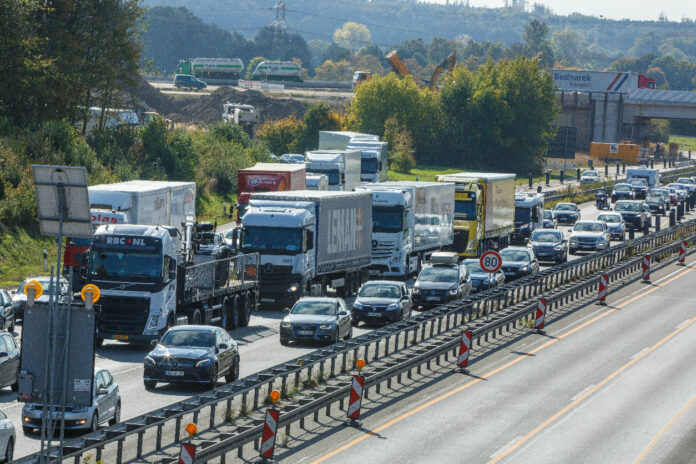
[18,220,696,464]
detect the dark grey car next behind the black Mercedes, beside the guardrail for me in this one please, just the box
[280,297,353,345]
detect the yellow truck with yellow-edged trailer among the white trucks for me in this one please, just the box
[436,172,515,258]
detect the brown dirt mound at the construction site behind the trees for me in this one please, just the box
[175,87,307,123]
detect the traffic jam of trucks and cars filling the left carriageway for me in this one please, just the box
[0,132,696,460]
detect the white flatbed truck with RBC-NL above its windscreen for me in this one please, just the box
[86,222,258,345]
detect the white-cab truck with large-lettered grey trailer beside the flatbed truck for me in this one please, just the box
[240,190,372,308]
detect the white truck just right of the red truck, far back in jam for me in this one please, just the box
[305,150,362,192]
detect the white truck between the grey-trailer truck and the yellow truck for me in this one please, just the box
[356,181,454,278]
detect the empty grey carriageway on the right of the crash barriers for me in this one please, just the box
[276,254,696,464]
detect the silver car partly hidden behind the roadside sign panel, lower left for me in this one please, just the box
[22,368,121,435]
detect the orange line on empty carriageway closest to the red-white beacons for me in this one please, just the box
[311,267,694,464]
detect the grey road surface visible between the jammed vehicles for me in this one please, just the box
[0,198,684,457]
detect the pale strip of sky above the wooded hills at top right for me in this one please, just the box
[429,0,696,21]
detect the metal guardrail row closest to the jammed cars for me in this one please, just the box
[18,216,696,464]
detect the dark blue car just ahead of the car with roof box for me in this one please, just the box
[352,280,412,326]
